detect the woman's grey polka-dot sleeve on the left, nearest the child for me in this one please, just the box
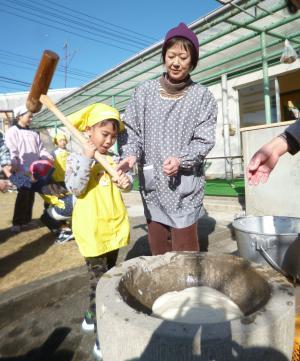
[118,88,144,159]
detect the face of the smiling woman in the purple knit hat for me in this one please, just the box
[165,43,192,83]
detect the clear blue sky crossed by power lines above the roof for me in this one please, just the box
[0,0,220,93]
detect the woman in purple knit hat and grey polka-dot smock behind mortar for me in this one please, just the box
[119,23,217,255]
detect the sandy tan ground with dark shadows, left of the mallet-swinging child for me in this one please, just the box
[0,192,84,292]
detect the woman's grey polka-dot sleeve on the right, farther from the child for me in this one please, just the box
[179,89,218,168]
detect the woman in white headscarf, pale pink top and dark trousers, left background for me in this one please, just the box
[5,106,53,232]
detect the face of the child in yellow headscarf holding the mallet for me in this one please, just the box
[87,122,118,154]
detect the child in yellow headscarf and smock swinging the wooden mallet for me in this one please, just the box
[65,103,132,359]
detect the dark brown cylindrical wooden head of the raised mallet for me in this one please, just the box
[26,50,59,113]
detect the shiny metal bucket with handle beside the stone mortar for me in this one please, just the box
[232,216,300,281]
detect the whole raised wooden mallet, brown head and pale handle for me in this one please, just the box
[26,50,118,179]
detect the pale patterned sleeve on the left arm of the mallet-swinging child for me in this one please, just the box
[65,153,93,197]
